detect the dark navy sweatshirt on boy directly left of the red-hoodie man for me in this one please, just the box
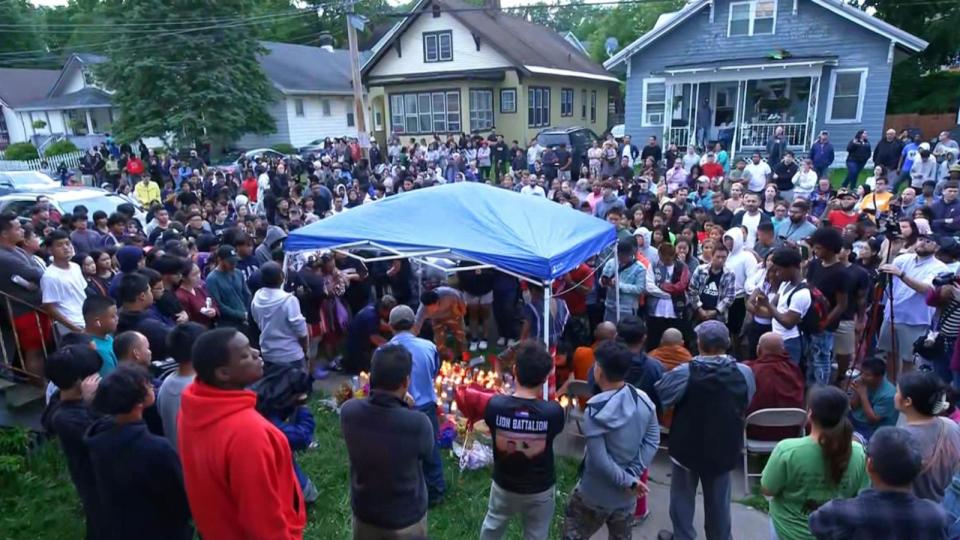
[84,417,193,540]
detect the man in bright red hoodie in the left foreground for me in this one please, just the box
[177,328,307,540]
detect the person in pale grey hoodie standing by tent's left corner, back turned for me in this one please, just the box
[250,262,307,371]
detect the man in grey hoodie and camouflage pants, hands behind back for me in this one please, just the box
[563,341,660,540]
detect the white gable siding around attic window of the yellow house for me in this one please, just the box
[369,12,511,77]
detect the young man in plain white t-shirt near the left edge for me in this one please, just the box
[40,230,87,335]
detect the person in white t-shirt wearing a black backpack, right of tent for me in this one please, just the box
[756,247,812,365]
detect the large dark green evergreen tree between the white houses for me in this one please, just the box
[96,0,275,144]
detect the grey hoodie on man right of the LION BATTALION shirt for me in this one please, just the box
[577,384,660,511]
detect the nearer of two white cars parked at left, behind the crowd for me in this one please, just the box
[0,187,147,227]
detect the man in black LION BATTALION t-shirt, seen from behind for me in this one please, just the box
[480,340,564,540]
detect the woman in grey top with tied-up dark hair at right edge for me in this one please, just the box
[893,371,960,503]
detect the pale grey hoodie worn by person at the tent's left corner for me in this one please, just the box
[250,287,307,362]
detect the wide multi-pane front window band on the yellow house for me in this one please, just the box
[390,90,462,135]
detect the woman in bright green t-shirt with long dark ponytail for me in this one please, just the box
[760,386,870,540]
